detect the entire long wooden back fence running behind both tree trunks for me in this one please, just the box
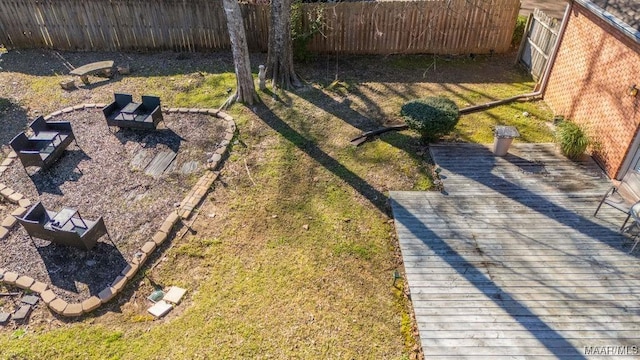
[0,0,520,54]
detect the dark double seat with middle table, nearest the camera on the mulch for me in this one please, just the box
[16,202,109,250]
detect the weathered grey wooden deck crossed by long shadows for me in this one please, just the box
[391,144,640,359]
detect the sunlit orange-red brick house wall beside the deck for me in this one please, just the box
[545,4,640,177]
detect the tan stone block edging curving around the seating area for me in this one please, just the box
[0,104,237,316]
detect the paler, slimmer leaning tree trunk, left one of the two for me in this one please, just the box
[222,0,260,107]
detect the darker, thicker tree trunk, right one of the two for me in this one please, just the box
[267,0,301,90]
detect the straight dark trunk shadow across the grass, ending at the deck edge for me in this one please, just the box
[256,104,390,215]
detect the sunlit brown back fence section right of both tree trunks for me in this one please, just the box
[307,0,520,54]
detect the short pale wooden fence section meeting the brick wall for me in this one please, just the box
[518,9,560,79]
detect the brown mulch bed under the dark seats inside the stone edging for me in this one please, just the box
[0,109,226,302]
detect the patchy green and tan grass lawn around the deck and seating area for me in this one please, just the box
[0,50,552,359]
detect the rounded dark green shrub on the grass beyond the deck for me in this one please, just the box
[400,97,460,141]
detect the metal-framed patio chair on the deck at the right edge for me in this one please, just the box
[593,170,640,231]
